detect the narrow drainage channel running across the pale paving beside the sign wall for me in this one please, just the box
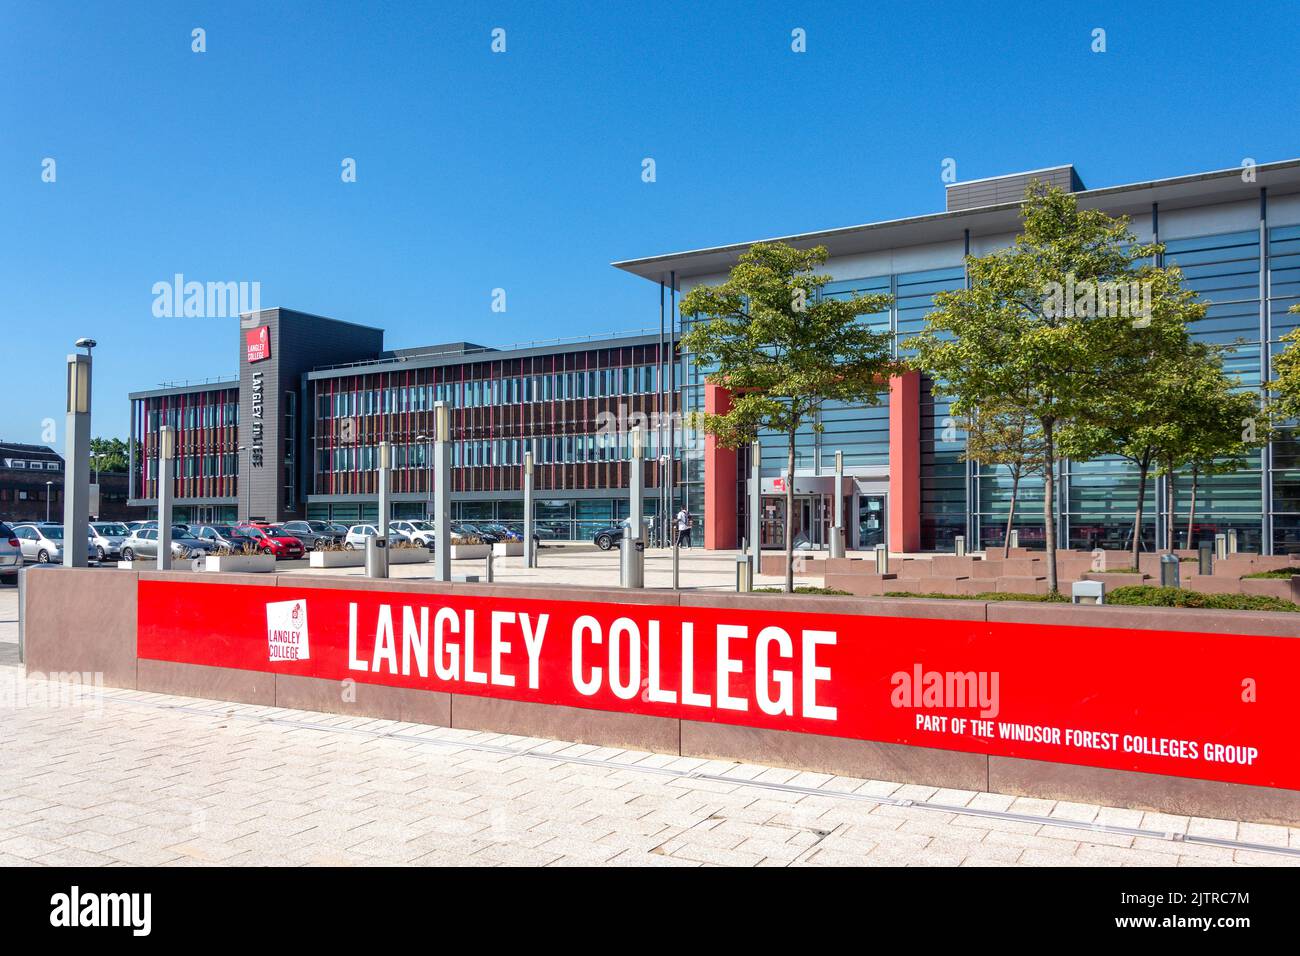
[108,696,1300,857]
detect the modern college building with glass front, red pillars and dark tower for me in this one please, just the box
[130,160,1300,553]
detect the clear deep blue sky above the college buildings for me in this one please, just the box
[0,0,1300,449]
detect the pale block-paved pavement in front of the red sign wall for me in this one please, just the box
[0,580,1300,866]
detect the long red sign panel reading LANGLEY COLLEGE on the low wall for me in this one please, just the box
[138,581,1300,790]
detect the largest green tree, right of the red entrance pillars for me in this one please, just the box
[906,183,1187,592]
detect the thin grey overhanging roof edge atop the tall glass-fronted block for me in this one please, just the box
[610,159,1300,281]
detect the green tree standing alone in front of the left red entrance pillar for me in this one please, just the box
[681,243,894,592]
